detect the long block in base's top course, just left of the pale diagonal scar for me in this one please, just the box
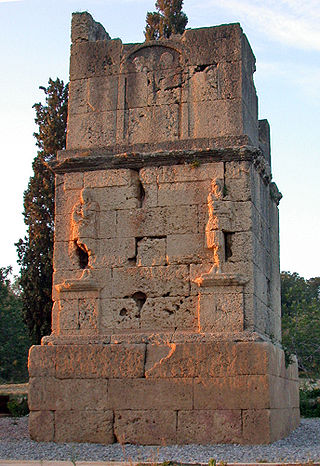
[56,344,145,379]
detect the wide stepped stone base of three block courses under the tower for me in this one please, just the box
[29,335,299,445]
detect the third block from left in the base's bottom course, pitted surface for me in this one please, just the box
[114,409,177,445]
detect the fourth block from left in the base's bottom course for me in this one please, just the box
[177,409,241,445]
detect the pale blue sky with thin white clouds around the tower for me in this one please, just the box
[0,0,320,278]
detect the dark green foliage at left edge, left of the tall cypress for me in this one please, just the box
[0,267,30,383]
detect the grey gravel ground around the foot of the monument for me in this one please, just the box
[0,417,320,463]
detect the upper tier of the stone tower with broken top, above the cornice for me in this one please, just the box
[67,13,259,150]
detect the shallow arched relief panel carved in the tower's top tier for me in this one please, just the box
[120,46,184,143]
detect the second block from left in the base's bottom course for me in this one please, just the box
[54,410,114,444]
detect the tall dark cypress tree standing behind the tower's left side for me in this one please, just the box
[16,79,68,344]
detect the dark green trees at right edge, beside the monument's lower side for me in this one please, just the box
[281,272,320,378]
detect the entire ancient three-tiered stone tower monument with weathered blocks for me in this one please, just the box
[29,13,299,444]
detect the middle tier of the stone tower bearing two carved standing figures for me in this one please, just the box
[53,157,280,336]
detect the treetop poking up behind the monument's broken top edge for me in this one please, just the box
[144,0,188,40]
